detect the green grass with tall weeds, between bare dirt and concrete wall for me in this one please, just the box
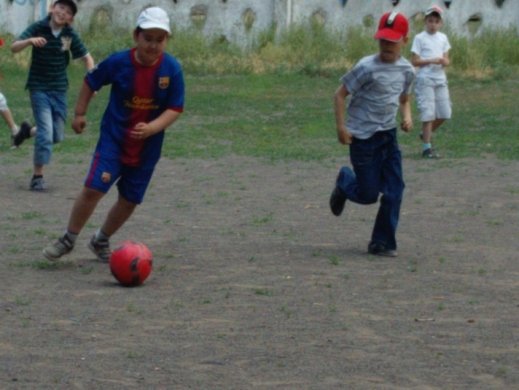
[0,24,519,161]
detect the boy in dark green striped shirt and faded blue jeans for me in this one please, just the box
[11,0,94,191]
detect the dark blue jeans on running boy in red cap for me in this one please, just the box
[336,129,405,250]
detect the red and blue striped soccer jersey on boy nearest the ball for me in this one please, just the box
[85,48,184,167]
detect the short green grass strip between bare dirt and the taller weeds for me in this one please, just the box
[0,67,519,160]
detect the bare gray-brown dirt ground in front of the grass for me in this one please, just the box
[0,152,519,389]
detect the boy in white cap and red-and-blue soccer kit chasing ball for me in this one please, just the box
[43,7,184,263]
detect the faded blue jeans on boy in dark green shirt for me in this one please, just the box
[31,91,67,165]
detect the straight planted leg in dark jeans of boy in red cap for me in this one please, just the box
[370,139,405,254]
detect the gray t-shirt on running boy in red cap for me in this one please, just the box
[341,54,415,139]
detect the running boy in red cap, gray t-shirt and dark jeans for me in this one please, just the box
[330,12,415,257]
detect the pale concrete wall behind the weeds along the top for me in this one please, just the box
[0,0,519,46]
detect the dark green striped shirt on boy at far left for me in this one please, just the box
[19,16,88,92]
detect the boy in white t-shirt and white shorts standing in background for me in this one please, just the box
[411,5,452,158]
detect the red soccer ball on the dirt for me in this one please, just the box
[109,241,153,287]
